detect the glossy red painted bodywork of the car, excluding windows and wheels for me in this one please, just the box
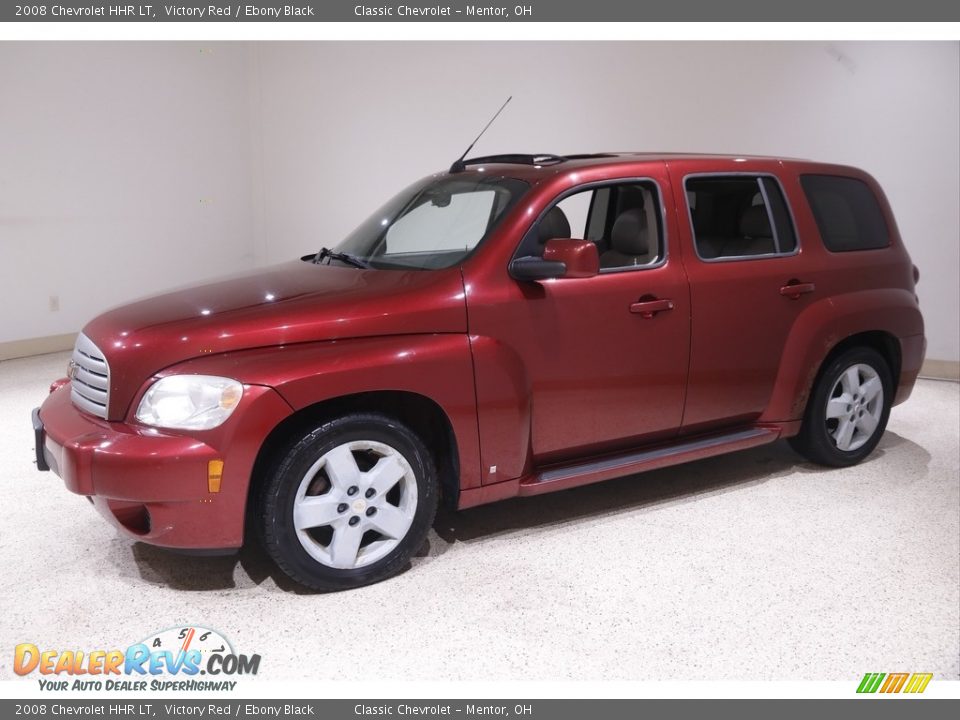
[35,154,925,548]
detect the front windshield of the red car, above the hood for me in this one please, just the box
[336,176,529,270]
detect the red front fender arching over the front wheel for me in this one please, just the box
[163,333,488,488]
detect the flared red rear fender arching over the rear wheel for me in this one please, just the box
[758,288,923,422]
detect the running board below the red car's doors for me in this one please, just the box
[519,427,780,495]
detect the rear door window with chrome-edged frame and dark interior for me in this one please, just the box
[685,175,797,260]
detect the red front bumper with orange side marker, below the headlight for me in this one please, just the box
[33,384,291,549]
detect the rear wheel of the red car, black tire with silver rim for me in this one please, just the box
[790,347,893,467]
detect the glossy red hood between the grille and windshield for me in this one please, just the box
[84,261,467,420]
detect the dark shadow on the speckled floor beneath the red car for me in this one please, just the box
[122,431,930,594]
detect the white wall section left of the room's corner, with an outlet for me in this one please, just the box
[0,42,253,342]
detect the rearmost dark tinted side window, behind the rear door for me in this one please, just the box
[800,175,890,252]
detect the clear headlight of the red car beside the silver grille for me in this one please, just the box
[137,375,243,430]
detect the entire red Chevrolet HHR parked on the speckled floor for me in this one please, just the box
[33,153,925,589]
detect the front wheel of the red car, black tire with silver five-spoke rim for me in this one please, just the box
[256,413,439,590]
